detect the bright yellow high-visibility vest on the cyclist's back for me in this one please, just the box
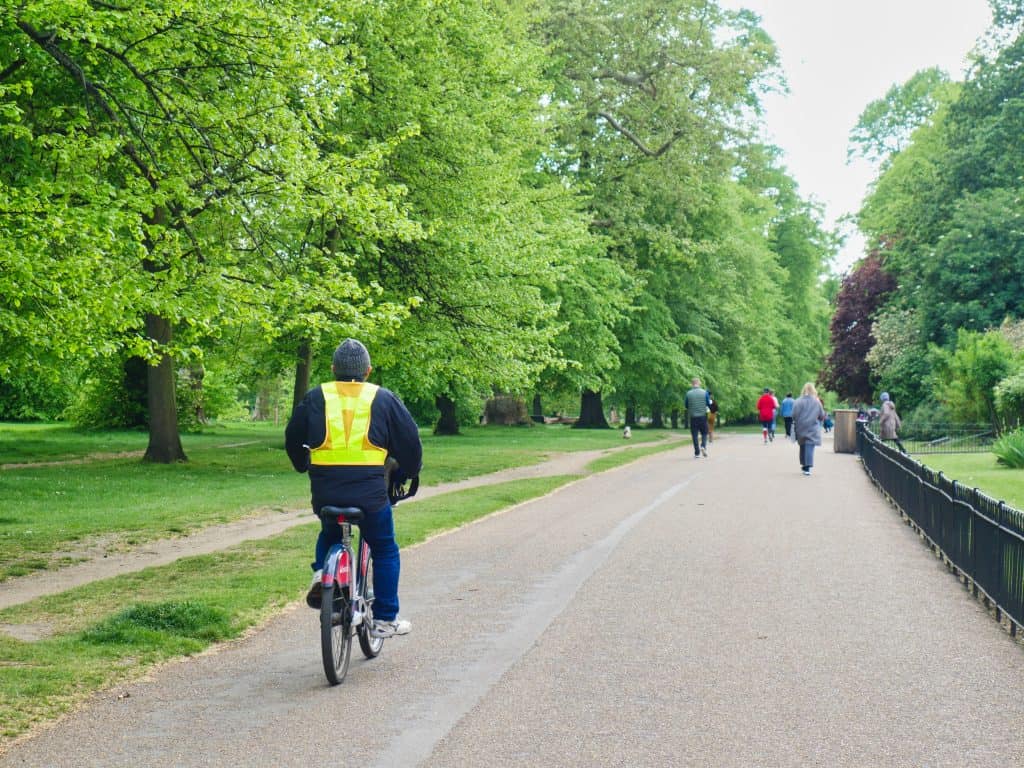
[309,381,387,467]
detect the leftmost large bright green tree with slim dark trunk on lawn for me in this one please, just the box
[0,0,391,462]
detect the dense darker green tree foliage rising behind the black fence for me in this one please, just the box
[854,6,1024,424]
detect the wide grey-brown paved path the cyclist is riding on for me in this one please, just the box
[0,436,1024,768]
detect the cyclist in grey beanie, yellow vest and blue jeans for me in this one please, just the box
[285,339,423,637]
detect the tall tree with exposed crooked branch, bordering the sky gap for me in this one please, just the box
[542,0,776,426]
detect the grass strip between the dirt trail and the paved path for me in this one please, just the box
[0,475,573,750]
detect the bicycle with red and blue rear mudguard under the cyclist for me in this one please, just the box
[319,472,419,685]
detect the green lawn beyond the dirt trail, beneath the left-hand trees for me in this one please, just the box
[0,424,667,581]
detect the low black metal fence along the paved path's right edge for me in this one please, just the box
[857,425,1024,637]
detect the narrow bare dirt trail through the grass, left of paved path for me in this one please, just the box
[0,434,685,614]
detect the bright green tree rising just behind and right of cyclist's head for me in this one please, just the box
[323,0,600,432]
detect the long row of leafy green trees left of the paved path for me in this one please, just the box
[0,0,836,462]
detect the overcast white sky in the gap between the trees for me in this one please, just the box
[720,0,991,272]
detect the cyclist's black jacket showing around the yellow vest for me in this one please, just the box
[285,387,423,512]
